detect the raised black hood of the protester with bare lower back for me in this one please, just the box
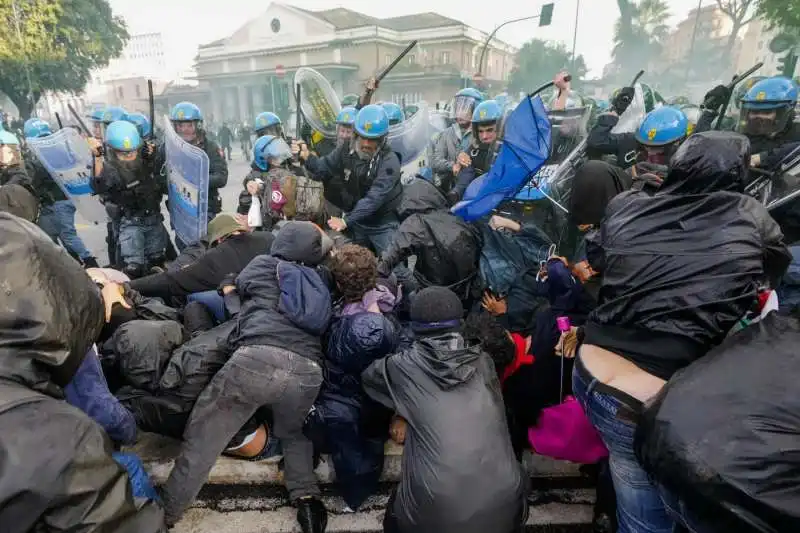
[659,131,750,194]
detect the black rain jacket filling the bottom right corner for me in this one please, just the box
[636,313,800,533]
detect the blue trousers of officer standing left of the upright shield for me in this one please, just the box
[119,213,167,268]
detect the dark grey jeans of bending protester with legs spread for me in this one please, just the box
[163,346,322,525]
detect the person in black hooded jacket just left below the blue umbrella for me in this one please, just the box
[379,178,480,300]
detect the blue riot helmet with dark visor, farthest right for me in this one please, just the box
[739,76,797,137]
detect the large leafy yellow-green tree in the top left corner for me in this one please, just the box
[0,0,128,118]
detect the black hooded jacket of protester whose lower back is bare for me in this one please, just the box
[584,132,791,380]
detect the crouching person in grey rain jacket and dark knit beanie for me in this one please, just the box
[362,287,527,533]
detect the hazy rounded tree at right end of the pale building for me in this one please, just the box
[508,39,589,92]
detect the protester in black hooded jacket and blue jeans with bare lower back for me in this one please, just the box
[573,132,789,533]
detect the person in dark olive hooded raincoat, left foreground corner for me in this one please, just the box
[0,213,165,533]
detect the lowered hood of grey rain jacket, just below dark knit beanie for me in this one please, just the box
[415,333,481,390]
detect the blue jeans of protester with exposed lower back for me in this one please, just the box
[572,362,674,533]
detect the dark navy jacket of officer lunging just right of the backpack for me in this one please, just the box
[305,144,403,226]
